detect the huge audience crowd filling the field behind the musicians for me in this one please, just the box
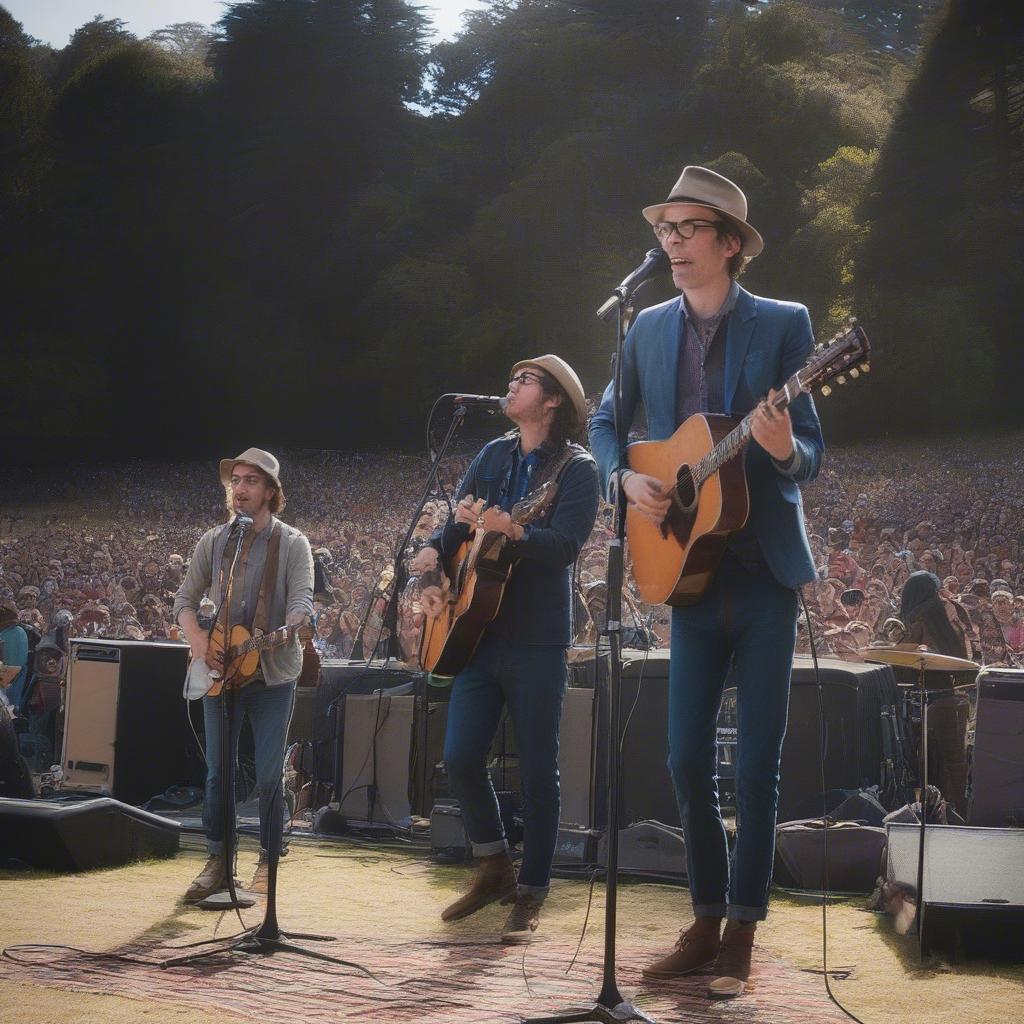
[0,437,1024,679]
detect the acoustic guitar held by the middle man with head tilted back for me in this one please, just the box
[420,480,558,676]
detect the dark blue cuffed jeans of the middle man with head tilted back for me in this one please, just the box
[444,636,566,898]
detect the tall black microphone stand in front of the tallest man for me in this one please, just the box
[523,283,654,1024]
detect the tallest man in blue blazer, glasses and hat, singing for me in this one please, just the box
[590,167,824,996]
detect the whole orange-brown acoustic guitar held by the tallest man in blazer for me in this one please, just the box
[626,321,870,605]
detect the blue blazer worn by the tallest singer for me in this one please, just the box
[590,288,824,588]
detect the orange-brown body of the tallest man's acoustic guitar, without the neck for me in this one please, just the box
[626,414,751,606]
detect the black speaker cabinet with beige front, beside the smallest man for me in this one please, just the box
[61,638,204,804]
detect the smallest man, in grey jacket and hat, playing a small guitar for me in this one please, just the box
[173,449,313,903]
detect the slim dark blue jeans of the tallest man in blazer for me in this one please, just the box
[669,553,797,921]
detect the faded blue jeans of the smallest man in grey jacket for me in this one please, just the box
[203,682,295,856]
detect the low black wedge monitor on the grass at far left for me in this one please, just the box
[0,797,180,871]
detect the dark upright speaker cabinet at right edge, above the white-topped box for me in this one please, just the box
[968,669,1024,827]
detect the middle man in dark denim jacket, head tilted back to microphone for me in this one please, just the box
[410,355,598,942]
